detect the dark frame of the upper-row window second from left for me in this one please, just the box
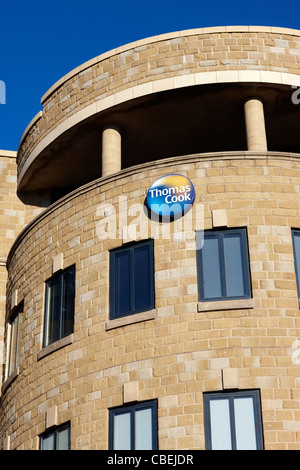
[43,264,76,348]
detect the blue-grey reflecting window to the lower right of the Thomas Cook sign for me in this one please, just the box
[197,229,251,302]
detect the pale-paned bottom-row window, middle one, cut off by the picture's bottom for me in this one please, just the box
[109,400,157,450]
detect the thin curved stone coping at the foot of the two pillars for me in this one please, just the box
[6,150,300,268]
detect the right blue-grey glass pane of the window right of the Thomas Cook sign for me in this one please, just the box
[224,233,245,297]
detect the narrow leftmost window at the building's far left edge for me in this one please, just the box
[8,302,23,376]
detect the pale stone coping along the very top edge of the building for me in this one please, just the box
[41,26,300,104]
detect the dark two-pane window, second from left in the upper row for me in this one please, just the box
[43,266,75,347]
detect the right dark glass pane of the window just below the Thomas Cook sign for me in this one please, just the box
[134,245,153,310]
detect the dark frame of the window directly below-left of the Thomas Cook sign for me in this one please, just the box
[109,238,155,320]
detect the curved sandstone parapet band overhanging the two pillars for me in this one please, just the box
[18,27,300,193]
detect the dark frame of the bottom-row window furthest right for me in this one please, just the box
[203,390,264,450]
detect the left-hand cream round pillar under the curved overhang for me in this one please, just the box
[102,125,121,176]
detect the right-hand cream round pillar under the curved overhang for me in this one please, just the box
[245,99,268,152]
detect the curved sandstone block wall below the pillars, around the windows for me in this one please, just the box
[0,152,300,450]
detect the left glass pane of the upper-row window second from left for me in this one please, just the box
[45,279,60,346]
